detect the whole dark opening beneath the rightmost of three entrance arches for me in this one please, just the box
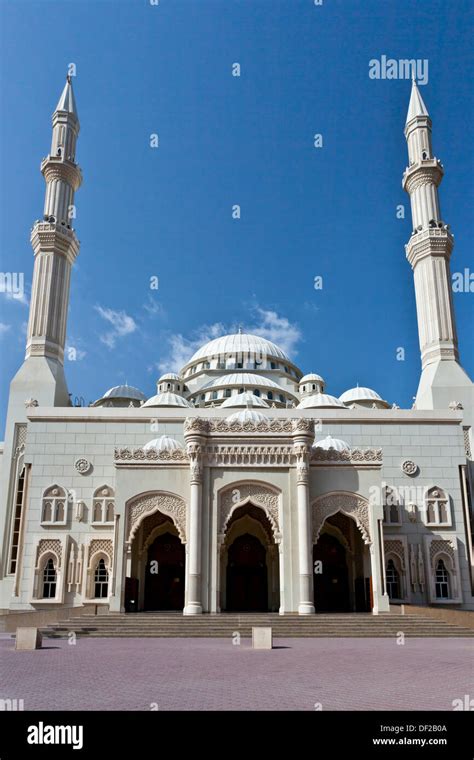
[313,511,372,612]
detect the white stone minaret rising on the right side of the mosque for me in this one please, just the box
[402,78,472,416]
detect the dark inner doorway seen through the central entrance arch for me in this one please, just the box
[226,533,268,612]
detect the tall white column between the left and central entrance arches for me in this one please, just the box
[183,443,202,615]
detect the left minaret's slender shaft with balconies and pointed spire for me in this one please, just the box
[22,76,82,405]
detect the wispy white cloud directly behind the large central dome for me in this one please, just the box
[157,306,301,372]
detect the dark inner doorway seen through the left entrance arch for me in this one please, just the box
[144,533,185,610]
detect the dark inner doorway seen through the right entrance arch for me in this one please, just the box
[313,533,350,612]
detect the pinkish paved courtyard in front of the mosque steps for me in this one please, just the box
[0,637,474,710]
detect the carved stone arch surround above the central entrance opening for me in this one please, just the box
[218,481,281,542]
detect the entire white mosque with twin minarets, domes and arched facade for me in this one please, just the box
[0,72,474,615]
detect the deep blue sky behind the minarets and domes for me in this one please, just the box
[0,0,474,428]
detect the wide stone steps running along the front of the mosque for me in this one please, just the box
[41,612,474,638]
